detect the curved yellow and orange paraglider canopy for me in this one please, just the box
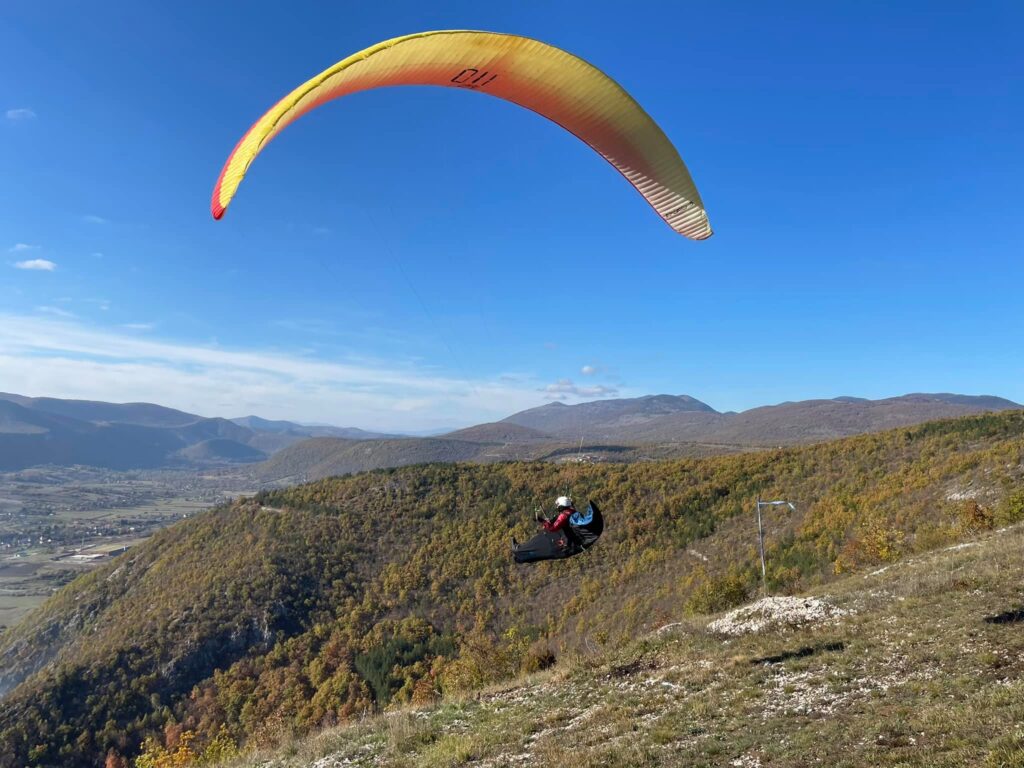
[211,30,712,240]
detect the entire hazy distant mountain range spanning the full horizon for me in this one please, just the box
[0,393,1024,481]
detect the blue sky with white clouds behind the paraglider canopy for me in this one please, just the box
[0,0,1024,430]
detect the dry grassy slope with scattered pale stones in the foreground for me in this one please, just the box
[224,526,1024,768]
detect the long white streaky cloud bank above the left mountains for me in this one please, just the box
[0,313,569,430]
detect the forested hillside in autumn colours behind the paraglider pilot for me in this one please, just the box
[0,412,1024,766]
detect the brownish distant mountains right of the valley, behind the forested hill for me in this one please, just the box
[249,393,1024,482]
